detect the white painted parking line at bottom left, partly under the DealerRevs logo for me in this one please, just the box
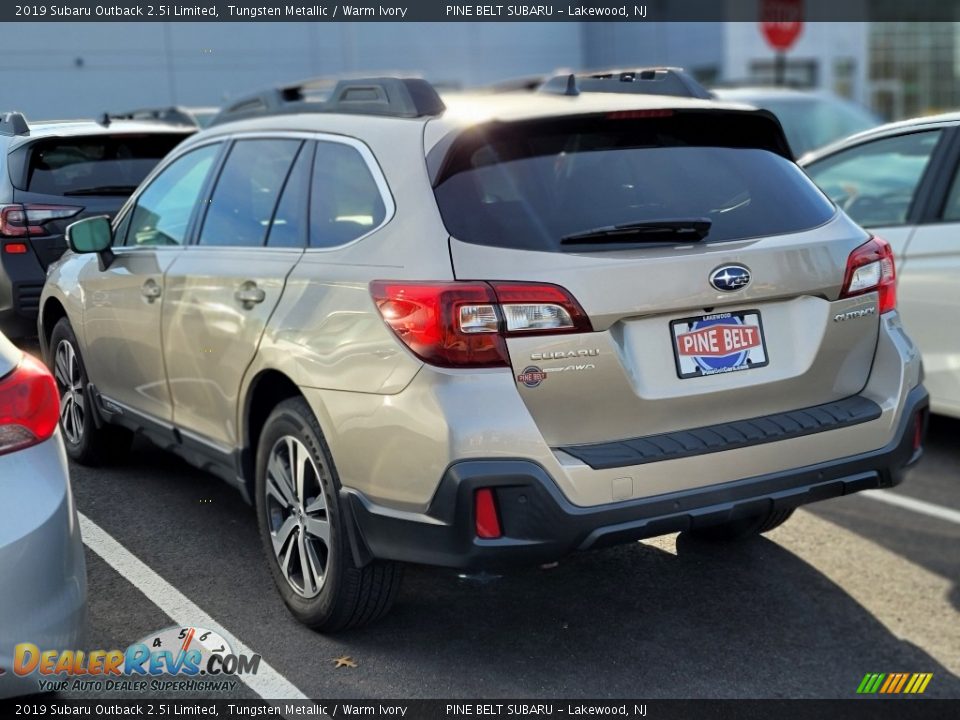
[77,513,307,700]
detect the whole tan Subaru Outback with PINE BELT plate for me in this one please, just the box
[41,73,927,631]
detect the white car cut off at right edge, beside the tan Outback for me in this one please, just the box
[799,113,960,418]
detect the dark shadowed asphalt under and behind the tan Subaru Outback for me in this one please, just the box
[74,442,960,699]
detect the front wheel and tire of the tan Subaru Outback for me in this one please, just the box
[48,318,133,466]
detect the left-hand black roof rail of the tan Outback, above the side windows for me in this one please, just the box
[210,77,446,125]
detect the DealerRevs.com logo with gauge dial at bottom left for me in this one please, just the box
[13,626,260,692]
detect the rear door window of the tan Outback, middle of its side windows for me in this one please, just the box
[199,139,303,247]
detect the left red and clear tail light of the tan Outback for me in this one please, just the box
[370,280,593,368]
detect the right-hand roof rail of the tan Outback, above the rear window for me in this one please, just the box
[538,67,713,100]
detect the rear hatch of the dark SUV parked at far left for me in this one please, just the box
[0,132,185,269]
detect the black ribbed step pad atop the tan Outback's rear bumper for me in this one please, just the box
[558,395,881,470]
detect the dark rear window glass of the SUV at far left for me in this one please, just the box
[22,134,185,195]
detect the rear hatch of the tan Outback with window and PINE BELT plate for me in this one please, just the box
[428,110,879,447]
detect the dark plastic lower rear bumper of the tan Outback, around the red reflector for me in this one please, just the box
[343,385,929,569]
